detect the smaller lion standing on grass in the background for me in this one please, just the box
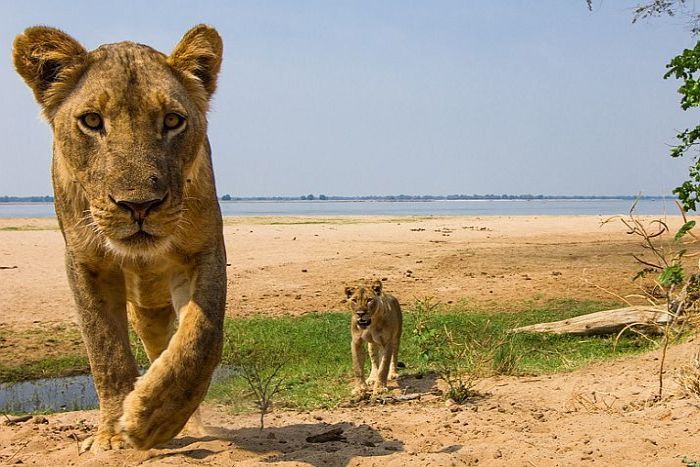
[345,281,403,395]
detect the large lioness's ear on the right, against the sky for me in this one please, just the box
[168,24,224,97]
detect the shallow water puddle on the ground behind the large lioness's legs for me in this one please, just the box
[0,367,236,413]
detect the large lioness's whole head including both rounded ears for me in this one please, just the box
[13,25,223,254]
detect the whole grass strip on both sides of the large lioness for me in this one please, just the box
[0,300,668,411]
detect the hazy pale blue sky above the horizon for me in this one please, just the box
[0,0,697,196]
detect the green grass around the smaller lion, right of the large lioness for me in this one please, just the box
[209,300,654,411]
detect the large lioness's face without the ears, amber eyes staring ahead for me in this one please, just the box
[53,43,206,253]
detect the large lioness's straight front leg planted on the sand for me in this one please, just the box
[66,256,138,452]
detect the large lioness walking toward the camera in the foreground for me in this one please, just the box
[13,25,226,452]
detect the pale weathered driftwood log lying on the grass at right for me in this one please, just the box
[513,306,671,336]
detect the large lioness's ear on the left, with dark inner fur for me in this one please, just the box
[12,26,87,116]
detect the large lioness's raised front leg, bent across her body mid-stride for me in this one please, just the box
[120,250,226,449]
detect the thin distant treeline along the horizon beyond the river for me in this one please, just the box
[0,194,675,203]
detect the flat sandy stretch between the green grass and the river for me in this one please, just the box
[0,216,677,328]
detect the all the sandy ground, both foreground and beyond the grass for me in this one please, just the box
[0,216,700,466]
